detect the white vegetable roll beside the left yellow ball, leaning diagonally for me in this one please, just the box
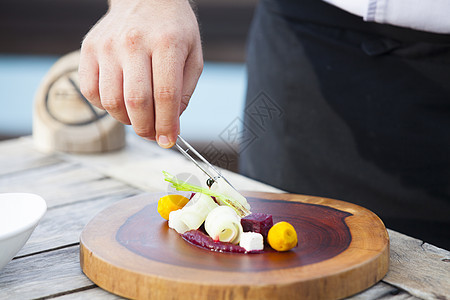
[169,193,219,234]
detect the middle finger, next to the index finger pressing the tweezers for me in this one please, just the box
[123,53,155,140]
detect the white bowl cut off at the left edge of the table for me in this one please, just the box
[0,193,47,270]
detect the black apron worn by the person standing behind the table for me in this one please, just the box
[239,0,450,249]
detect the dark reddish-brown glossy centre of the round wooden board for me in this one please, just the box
[116,198,352,272]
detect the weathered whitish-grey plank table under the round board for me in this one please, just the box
[0,135,450,299]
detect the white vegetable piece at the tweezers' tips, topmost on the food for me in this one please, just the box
[211,178,250,217]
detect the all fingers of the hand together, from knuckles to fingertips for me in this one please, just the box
[79,41,203,148]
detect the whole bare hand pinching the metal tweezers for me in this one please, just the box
[78,0,203,148]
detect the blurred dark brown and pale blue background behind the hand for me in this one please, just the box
[0,0,257,169]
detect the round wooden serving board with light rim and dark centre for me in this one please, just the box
[80,192,389,300]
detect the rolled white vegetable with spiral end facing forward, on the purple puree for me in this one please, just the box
[205,206,242,244]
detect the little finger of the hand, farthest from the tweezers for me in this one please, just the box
[78,43,103,109]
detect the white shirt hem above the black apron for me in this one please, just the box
[323,0,450,34]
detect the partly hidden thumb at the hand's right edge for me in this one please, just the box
[180,43,203,115]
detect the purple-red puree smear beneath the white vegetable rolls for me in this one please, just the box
[181,230,262,253]
